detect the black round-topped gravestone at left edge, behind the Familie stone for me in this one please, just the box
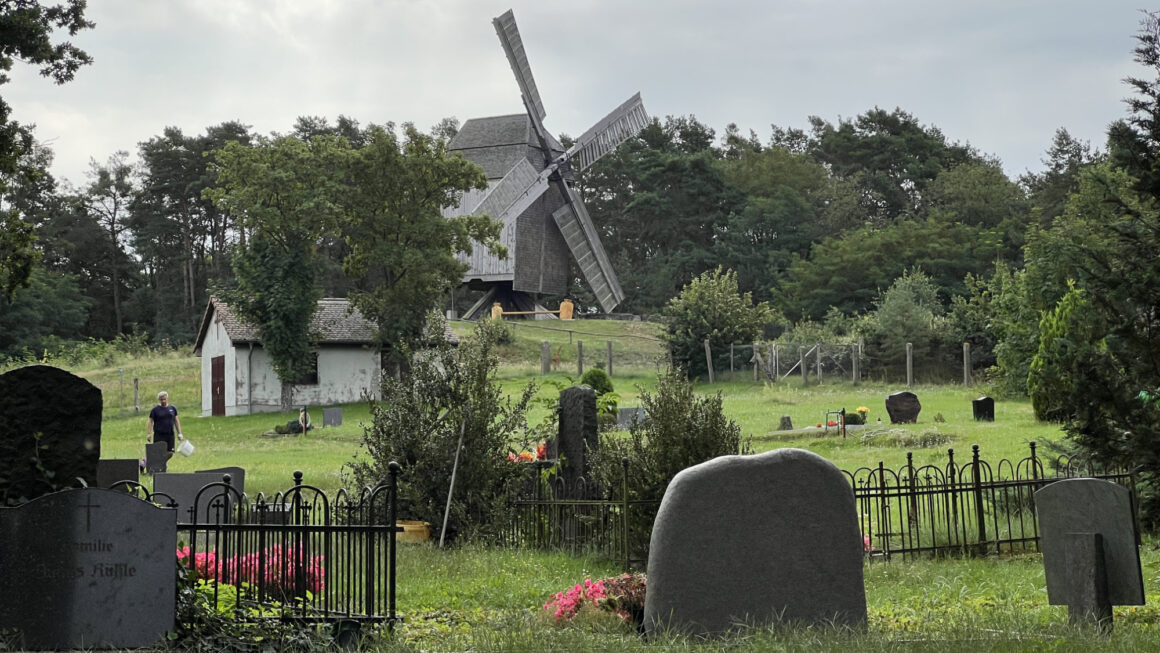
[0,365,102,506]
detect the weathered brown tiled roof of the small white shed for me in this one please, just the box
[194,297,459,353]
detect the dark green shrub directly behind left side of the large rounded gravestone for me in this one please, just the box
[593,368,753,552]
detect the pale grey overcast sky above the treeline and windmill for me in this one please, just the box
[0,0,1151,184]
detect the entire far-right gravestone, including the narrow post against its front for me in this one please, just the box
[1035,478,1144,625]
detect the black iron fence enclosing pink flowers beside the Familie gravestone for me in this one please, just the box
[113,463,403,626]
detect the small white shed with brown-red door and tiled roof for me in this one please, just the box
[194,297,382,415]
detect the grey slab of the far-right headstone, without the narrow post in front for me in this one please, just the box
[1035,478,1144,605]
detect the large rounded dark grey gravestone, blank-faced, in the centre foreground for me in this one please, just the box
[644,449,867,634]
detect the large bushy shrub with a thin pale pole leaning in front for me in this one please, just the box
[343,320,536,538]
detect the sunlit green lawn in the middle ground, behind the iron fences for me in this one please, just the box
[22,320,1061,493]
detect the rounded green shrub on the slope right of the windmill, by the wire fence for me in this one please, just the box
[664,268,774,376]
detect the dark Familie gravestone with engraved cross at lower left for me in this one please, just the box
[0,488,177,651]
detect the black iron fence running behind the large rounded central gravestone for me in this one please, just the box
[501,442,1136,568]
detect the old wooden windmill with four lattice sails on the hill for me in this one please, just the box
[447,9,648,319]
